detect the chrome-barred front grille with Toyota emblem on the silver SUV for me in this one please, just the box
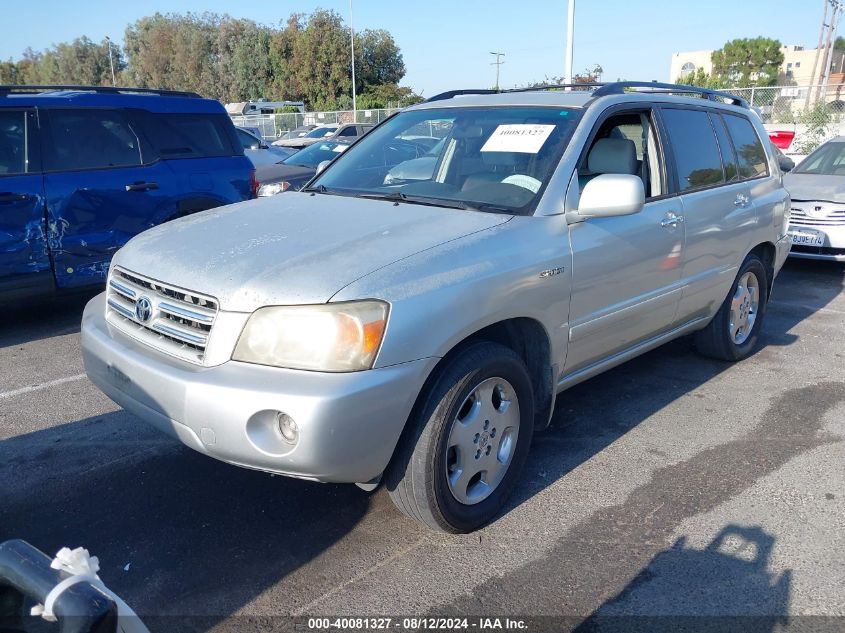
[106,267,218,365]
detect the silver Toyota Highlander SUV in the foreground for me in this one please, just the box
[82,82,789,532]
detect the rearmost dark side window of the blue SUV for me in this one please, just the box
[142,112,237,159]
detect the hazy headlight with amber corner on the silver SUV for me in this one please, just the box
[232,300,388,372]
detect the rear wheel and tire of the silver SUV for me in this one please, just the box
[695,254,769,362]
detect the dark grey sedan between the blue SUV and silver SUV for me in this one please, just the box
[255,138,355,198]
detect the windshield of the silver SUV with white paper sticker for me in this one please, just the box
[311,106,580,213]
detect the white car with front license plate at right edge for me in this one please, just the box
[783,136,845,262]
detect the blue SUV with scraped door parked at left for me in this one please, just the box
[0,86,257,299]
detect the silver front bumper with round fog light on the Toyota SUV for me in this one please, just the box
[81,295,438,483]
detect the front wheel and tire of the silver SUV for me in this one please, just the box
[385,342,534,533]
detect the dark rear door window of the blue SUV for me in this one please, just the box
[45,109,141,171]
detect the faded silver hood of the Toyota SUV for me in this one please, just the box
[114,192,511,312]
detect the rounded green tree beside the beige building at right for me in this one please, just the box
[711,37,783,88]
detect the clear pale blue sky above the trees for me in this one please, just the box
[0,0,824,96]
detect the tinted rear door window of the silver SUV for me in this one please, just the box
[663,108,725,191]
